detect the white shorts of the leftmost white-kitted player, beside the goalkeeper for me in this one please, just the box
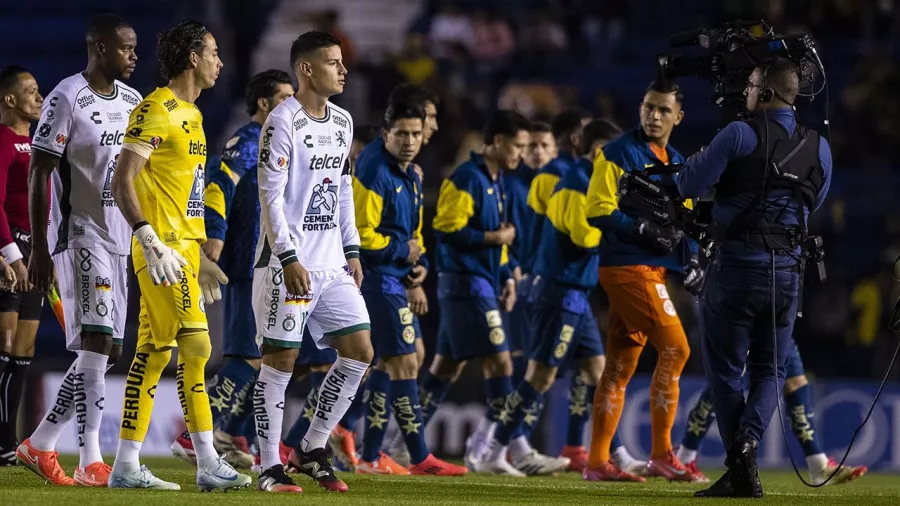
[53,248,128,351]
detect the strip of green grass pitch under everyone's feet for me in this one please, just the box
[0,456,900,506]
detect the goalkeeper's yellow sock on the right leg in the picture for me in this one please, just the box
[178,331,213,433]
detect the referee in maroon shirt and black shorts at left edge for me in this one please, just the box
[0,66,46,466]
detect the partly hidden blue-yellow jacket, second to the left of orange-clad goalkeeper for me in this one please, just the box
[516,151,575,274]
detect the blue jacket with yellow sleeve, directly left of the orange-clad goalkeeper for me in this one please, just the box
[534,158,603,291]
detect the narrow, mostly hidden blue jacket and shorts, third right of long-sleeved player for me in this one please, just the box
[503,162,538,356]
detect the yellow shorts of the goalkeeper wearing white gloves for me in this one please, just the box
[132,241,209,349]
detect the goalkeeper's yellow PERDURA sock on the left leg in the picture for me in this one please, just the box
[119,345,172,442]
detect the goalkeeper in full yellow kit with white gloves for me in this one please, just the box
[109,21,251,491]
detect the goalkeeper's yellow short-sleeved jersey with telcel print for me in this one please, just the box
[125,88,206,271]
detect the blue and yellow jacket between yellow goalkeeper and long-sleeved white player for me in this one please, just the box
[204,121,262,280]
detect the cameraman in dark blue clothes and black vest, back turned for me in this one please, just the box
[676,58,831,497]
